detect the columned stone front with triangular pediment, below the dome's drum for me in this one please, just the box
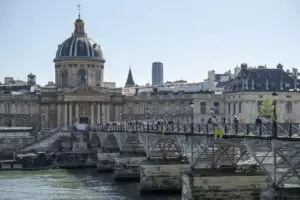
[41,84,123,128]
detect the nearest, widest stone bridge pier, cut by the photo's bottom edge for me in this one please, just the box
[181,169,268,200]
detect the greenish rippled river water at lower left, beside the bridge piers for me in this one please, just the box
[0,169,181,200]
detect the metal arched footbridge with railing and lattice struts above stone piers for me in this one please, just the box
[88,124,300,187]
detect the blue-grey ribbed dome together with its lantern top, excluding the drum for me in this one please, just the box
[54,17,104,61]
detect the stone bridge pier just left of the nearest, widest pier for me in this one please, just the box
[140,159,189,192]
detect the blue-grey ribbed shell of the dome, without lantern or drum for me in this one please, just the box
[56,36,103,59]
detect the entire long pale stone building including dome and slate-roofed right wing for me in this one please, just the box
[0,17,300,129]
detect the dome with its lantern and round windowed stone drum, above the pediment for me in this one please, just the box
[54,16,105,87]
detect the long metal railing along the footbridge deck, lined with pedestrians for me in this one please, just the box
[89,123,300,137]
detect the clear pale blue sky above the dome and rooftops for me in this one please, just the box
[0,0,300,87]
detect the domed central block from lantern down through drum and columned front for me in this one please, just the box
[40,15,123,128]
